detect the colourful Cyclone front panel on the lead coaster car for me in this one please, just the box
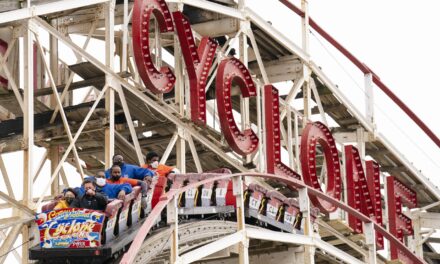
[35,208,105,248]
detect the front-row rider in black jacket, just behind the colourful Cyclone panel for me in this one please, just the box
[70,179,107,211]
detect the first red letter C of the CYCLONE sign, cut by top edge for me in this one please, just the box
[132,0,176,94]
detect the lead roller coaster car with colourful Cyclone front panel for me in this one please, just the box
[29,186,145,263]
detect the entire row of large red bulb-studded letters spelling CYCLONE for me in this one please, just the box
[132,0,417,263]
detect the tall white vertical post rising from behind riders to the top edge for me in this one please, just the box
[104,0,115,168]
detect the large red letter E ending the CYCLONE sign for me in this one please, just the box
[387,176,417,259]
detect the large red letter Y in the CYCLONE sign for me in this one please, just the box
[173,12,217,124]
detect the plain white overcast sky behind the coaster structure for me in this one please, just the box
[0,0,440,260]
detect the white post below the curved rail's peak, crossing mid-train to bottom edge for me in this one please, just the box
[232,176,249,264]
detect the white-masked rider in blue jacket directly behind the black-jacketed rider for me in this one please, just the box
[78,171,133,200]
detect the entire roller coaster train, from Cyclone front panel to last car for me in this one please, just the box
[29,169,319,263]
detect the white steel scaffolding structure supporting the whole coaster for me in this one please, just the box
[0,0,440,263]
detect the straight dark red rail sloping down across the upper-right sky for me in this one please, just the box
[279,0,440,148]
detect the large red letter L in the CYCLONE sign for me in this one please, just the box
[264,85,301,180]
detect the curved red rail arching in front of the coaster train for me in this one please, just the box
[120,172,425,264]
